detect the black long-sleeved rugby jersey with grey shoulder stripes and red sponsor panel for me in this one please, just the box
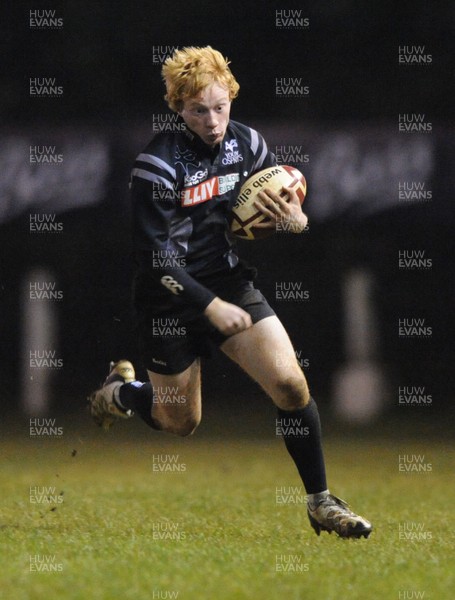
[130,120,276,310]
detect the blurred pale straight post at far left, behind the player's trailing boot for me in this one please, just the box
[21,268,57,417]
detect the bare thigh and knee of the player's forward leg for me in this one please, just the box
[221,316,309,410]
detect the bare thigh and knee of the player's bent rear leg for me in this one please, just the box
[147,358,201,435]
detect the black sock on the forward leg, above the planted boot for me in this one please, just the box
[277,398,327,494]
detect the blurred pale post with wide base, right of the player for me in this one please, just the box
[333,270,386,424]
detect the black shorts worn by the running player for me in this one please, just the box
[135,265,275,375]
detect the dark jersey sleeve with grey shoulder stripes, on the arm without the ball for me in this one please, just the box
[130,153,216,311]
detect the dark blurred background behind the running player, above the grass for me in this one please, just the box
[0,0,455,432]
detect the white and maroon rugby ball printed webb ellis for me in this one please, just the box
[231,165,306,240]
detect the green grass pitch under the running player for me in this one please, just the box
[0,428,454,600]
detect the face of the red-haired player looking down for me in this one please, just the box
[179,83,231,148]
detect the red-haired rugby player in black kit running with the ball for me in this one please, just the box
[89,46,372,538]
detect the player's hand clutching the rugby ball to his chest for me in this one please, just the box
[254,187,308,233]
